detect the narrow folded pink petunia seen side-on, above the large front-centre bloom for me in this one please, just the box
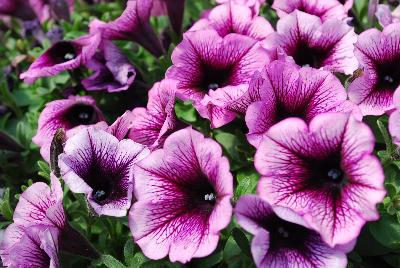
[128,79,182,149]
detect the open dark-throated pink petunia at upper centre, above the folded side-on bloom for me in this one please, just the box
[166,30,269,127]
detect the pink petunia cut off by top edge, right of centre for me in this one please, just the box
[272,0,348,23]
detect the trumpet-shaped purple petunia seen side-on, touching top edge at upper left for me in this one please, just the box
[90,0,164,57]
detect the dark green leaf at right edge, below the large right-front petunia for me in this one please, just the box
[369,214,400,249]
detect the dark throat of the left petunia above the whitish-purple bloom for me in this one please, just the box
[64,104,99,128]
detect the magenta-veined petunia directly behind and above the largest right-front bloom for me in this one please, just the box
[246,61,356,146]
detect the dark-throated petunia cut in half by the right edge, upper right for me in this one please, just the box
[349,23,400,115]
